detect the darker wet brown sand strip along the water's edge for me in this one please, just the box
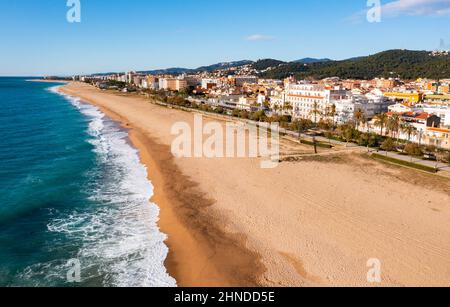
[59,86,265,287]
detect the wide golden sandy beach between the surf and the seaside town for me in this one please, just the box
[61,82,450,286]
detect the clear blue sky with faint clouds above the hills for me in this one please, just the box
[0,0,450,76]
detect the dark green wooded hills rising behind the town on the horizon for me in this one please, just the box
[89,49,450,79]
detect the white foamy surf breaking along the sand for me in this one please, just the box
[44,87,176,287]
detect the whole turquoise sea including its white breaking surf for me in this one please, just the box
[0,78,176,286]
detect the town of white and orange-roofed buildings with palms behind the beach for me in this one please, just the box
[57,53,450,159]
